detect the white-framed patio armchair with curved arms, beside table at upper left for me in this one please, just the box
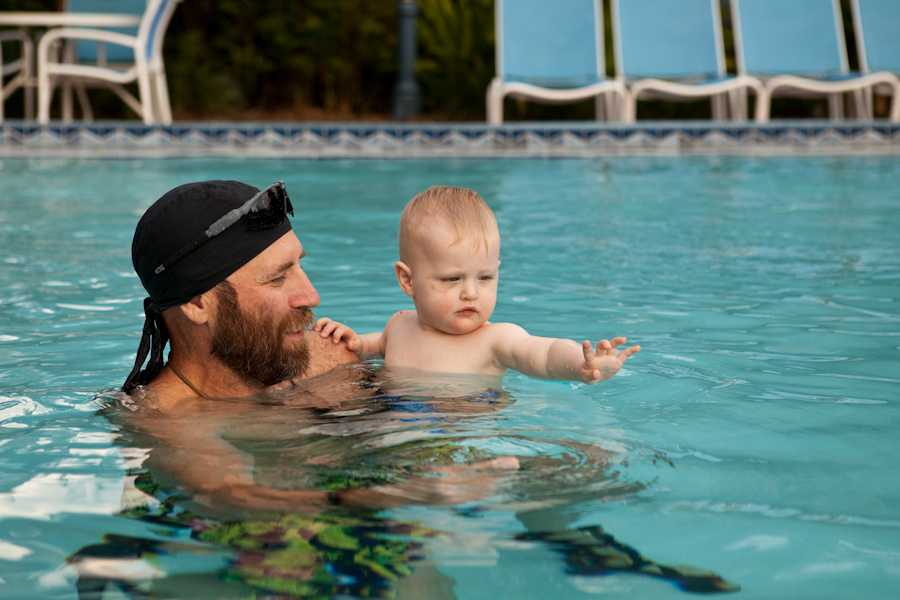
[38,0,181,125]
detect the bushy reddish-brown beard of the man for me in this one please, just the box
[212,281,315,387]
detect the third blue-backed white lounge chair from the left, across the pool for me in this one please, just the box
[731,0,900,121]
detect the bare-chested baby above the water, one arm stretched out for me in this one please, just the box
[314,186,640,384]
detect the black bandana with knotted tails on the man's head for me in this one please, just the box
[123,181,291,392]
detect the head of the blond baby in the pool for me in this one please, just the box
[395,186,500,334]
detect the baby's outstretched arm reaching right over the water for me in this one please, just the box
[493,323,641,385]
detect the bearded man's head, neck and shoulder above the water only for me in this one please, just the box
[124,181,357,405]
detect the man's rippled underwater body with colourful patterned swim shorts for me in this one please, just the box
[67,365,740,600]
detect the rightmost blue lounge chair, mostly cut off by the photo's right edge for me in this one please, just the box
[850,0,900,121]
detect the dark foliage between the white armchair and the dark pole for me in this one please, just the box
[165,0,397,115]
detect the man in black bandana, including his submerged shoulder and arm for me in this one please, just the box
[121,181,518,510]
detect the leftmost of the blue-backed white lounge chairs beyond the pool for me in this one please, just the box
[487,0,627,125]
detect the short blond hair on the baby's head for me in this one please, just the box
[400,185,498,263]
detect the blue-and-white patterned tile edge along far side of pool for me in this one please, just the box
[0,119,900,159]
